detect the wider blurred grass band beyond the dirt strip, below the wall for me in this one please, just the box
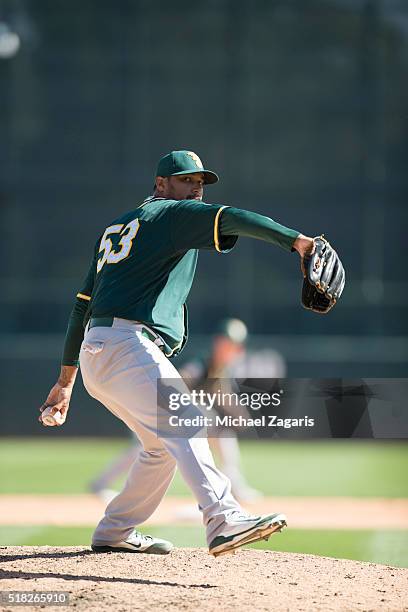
[0,438,408,497]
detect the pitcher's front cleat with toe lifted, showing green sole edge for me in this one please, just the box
[208,513,286,557]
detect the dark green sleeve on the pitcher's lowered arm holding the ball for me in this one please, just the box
[61,246,98,367]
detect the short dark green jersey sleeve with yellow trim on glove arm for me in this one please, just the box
[170,200,238,253]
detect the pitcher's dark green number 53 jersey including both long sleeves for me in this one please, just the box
[62,197,299,365]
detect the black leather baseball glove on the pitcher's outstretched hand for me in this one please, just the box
[302,236,346,314]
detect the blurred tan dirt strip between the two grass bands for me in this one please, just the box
[0,495,408,529]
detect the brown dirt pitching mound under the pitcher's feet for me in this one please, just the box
[0,546,408,612]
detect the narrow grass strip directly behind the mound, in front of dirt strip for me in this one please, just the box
[0,525,408,567]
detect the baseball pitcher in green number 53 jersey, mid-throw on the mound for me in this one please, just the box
[40,151,344,556]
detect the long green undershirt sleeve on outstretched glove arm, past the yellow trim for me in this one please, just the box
[219,207,300,251]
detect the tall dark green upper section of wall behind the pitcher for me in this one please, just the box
[0,0,408,436]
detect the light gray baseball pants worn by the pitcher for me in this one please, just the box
[81,327,241,541]
